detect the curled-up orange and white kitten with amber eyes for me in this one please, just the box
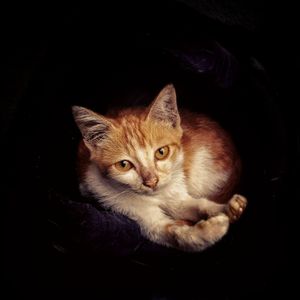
[72,84,247,252]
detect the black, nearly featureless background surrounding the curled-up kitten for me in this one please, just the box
[1,1,299,299]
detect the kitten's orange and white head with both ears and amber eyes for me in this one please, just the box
[73,85,183,194]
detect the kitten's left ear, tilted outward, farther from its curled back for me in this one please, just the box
[72,106,112,148]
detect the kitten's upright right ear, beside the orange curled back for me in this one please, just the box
[147,84,180,128]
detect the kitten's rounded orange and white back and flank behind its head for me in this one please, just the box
[180,111,240,202]
